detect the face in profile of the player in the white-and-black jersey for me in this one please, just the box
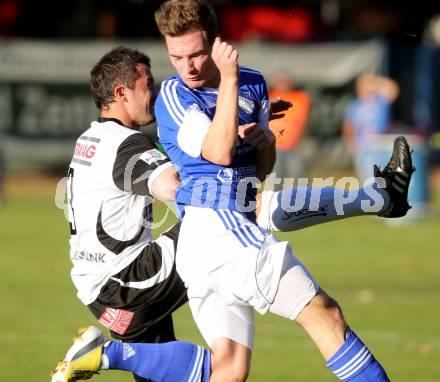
[126,64,156,126]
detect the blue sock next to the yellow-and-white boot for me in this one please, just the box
[102,341,211,382]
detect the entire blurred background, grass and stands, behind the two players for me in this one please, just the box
[0,0,440,381]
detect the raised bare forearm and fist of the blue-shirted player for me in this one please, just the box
[202,38,239,166]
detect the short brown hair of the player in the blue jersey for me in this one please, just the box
[154,0,217,44]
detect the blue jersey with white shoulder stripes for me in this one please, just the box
[155,67,269,218]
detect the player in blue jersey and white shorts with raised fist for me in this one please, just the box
[155,0,412,382]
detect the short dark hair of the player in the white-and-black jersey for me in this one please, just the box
[90,46,150,110]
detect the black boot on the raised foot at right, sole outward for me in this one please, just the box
[374,136,415,218]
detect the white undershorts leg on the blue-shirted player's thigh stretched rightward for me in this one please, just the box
[269,246,319,320]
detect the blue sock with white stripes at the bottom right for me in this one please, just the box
[326,331,389,382]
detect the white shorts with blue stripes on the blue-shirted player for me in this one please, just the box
[176,206,317,349]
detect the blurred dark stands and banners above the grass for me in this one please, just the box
[0,0,440,213]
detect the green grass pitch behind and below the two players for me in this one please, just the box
[0,178,440,382]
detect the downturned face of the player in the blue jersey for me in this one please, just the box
[165,30,218,88]
